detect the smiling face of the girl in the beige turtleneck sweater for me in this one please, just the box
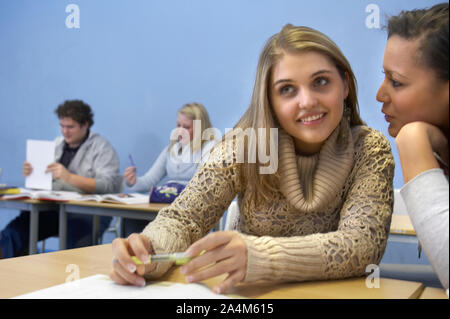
[269,51,348,155]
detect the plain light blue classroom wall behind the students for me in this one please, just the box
[0,0,440,239]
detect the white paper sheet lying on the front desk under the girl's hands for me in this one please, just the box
[13,275,229,299]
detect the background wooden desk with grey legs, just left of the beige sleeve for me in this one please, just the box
[59,201,169,250]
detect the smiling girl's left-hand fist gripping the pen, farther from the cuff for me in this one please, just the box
[109,234,156,287]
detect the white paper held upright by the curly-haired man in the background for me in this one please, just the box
[25,140,55,190]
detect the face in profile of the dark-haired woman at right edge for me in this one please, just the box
[377,35,449,137]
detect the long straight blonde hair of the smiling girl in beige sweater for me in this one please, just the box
[230,24,364,205]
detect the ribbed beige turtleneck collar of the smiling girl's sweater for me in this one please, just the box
[279,119,353,213]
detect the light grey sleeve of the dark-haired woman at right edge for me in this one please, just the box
[400,169,449,289]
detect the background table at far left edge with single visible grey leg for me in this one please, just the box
[0,198,58,254]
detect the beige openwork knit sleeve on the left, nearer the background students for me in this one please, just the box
[142,141,241,278]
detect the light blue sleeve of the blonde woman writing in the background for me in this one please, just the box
[127,147,169,193]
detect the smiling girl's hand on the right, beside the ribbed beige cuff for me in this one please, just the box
[180,231,247,293]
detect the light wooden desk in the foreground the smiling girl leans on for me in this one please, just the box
[0,244,424,299]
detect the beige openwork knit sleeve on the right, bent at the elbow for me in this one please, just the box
[242,133,394,282]
